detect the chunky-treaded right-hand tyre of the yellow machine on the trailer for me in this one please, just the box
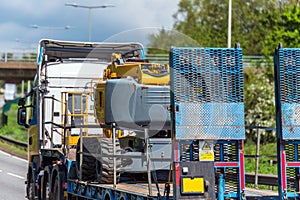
[96,138,121,183]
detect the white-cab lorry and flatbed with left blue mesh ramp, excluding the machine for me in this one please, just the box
[18,40,245,200]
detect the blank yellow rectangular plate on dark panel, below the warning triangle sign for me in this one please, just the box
[181,177,205,194]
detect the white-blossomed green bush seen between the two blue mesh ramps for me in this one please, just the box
[244,66,276,143]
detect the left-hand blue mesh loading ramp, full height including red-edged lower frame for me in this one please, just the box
[170,45,245,199]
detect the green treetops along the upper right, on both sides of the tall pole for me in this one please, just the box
[150,0,300,55]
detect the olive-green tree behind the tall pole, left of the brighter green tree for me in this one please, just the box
[174,0,279,55]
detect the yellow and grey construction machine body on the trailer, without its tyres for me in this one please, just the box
[94,51,171,180]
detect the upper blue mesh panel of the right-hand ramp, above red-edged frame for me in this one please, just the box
[274,48,300,139]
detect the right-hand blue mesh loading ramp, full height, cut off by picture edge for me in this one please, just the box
[274,44,300,199]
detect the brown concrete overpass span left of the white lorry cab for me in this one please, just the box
[0,61,36,82]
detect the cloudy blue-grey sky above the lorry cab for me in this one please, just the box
[0,0,180,52]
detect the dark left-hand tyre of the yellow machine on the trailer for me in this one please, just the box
[76,137,99,181]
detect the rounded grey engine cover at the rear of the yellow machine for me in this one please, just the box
[105,78,170,130]
